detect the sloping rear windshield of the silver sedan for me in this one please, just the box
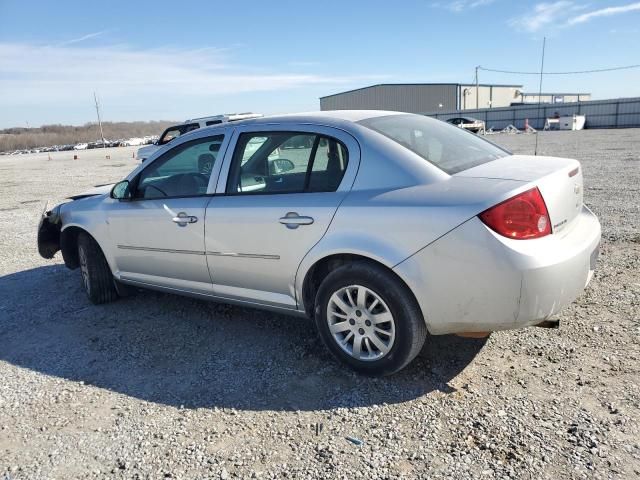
[358,114,509,175]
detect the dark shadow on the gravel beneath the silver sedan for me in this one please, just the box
[0,265,485,410]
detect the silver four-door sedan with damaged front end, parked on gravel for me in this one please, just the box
[38,111,600,375]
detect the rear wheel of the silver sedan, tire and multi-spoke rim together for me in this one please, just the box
[315,262,427,375]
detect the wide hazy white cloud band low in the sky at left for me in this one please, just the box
[0,42,384,106]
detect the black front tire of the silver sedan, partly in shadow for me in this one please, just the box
[78,232,118,305]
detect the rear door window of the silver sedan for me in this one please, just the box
[227,132,348,195]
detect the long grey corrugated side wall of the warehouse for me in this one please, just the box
[320,84,458,113]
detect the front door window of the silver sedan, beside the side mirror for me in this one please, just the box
[135,135,224,199]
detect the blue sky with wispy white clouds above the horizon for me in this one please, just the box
[0,0,640,128]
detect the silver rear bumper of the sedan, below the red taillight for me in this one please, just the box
[394,207,601,334]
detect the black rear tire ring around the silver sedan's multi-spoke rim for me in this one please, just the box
[314,261,427,376]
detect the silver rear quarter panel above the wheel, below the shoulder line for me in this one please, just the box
[296,177,526,308]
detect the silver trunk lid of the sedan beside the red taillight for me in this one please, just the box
[455,155,583,233]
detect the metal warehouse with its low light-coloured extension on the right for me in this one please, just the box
[320,83,590,113]
